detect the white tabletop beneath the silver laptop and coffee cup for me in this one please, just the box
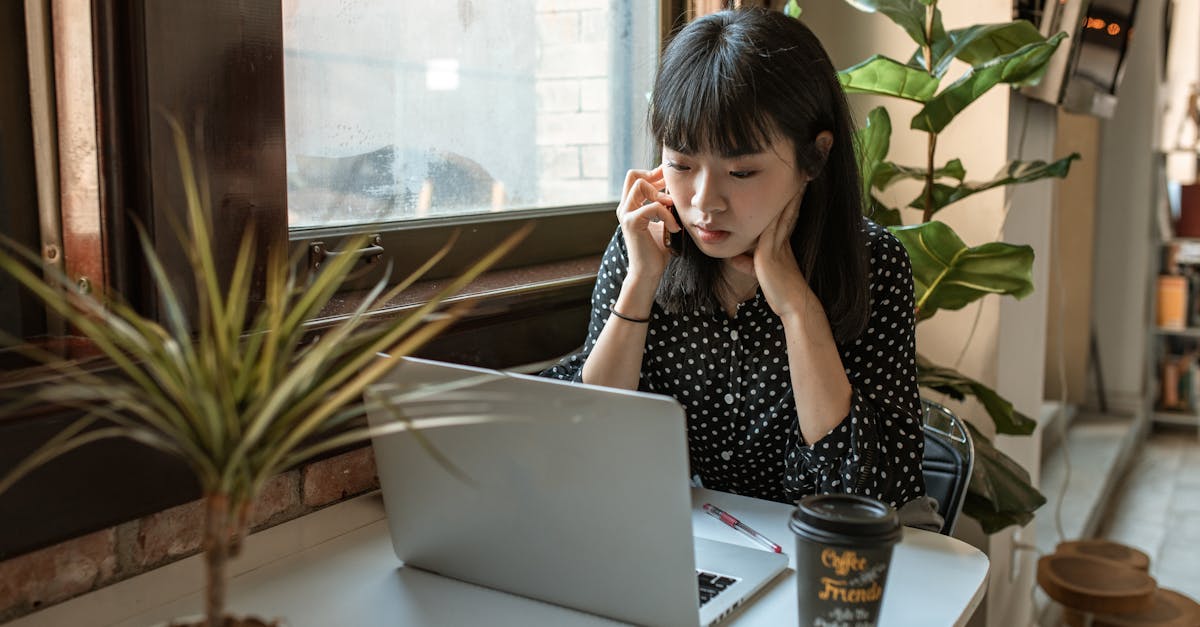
[11,490,988,627]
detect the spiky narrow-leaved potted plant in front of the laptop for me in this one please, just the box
[0,120,529,626]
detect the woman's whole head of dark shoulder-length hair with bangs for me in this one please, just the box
[649,8,870,342]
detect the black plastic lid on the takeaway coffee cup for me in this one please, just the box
[791,494,901,544]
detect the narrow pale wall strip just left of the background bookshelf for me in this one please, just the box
[1088,0,1164,413]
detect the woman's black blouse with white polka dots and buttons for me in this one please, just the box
[542,219,924,507]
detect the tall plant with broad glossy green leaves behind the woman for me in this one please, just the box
[785,0,1079,533]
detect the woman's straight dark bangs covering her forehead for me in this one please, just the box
[649,20,776,156]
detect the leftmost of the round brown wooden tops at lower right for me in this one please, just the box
[1038,553,1158,614]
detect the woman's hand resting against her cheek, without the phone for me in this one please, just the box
[730,189,816,320]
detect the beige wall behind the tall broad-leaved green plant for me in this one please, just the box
[802,0,1055,626]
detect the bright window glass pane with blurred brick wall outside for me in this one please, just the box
[283,0,659,228]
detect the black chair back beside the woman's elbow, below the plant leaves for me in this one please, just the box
[920,399,974,536]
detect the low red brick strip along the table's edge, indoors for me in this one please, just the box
[0,447,379,622]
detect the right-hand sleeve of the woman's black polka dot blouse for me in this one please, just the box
[785,227,925,507]
